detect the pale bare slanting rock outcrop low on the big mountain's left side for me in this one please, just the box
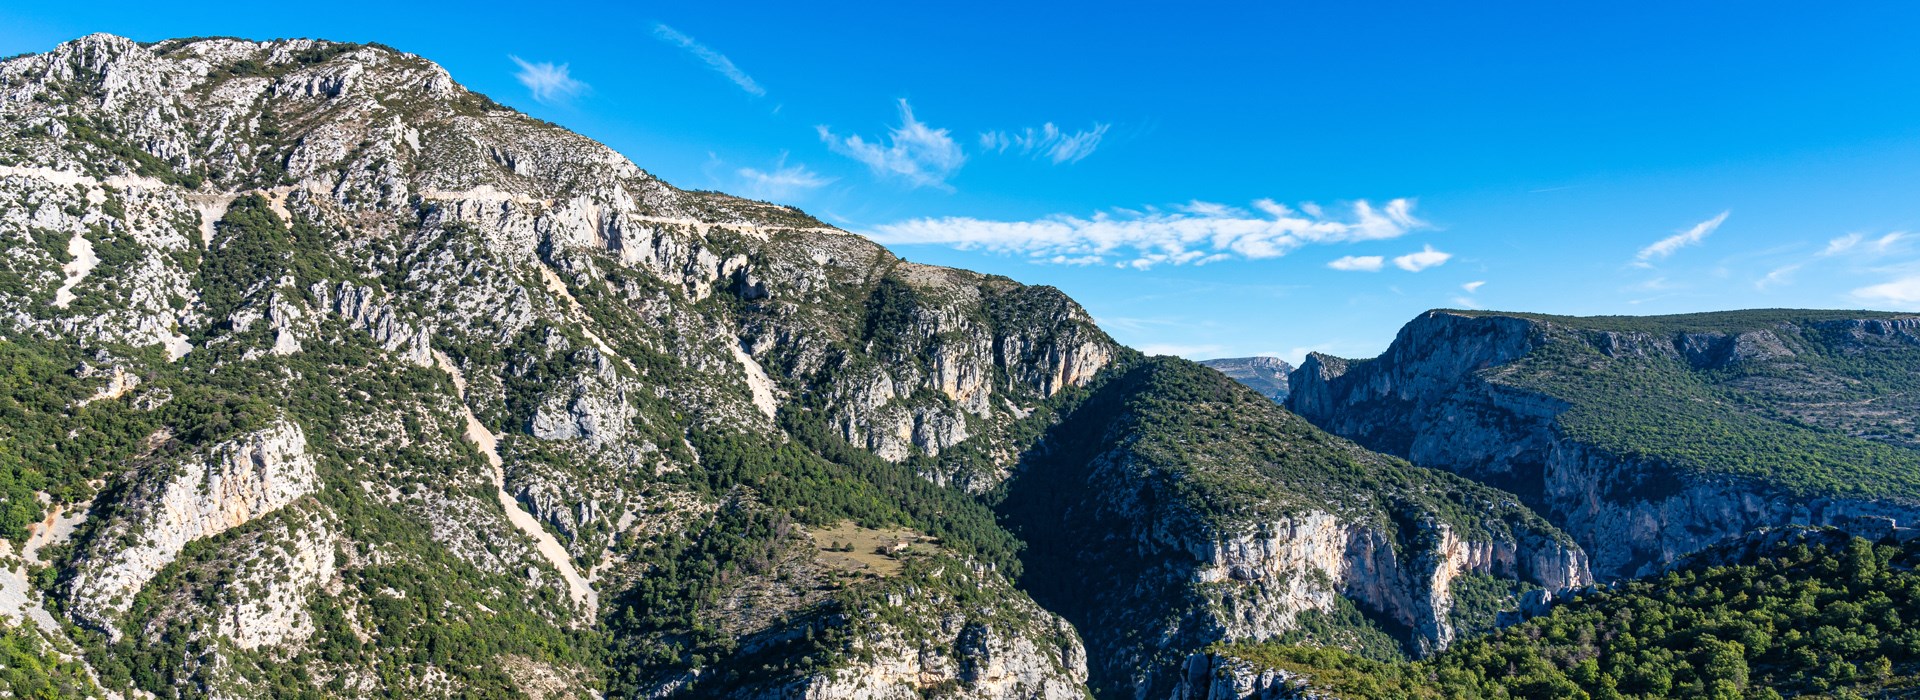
[71,422,316,637]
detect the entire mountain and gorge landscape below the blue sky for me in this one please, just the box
[0,35,1920,700]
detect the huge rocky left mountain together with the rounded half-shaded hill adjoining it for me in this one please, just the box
[0,35,1590,698]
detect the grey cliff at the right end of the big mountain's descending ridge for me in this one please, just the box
[741,253,1121,491]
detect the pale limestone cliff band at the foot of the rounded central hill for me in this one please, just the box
[1059,452,1592,688]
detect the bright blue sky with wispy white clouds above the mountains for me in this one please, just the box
[0,2,1920,359]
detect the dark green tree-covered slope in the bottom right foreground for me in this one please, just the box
[1177,527,1920,700]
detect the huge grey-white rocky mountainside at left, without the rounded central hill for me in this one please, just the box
[0,35,1114,698]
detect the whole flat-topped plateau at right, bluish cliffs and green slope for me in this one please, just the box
[1288,311,1920,579]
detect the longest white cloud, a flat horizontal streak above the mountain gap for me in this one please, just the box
[870,199,1446,268]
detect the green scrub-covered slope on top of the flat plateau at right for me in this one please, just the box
[1469,309,1920,499]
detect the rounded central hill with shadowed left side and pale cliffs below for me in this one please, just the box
[1002,359,1588,698]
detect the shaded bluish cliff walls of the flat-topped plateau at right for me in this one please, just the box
[1288,311,1920,579]
